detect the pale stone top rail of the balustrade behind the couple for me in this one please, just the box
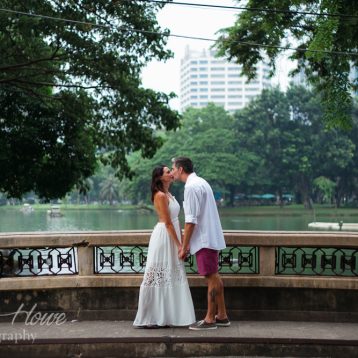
[0,230,358,249]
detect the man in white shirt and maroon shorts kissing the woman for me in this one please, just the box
[172,157,230,330]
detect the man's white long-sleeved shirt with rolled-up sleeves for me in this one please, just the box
[183,173,226,255]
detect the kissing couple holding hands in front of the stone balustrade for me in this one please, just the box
[133,157,230,330]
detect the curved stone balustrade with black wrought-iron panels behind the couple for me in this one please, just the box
[0,230,358,291]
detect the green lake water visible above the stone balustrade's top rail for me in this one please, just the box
[0,208,358,232]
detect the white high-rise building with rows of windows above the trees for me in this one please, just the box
[180,47,271,112]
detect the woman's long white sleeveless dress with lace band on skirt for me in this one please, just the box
[133,197,195,326]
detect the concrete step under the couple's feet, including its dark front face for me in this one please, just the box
[0,321,358,358]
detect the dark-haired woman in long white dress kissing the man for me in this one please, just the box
[133,165,195,328]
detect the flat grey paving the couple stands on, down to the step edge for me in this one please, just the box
[0,321,358,344]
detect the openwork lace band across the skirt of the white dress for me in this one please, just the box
[142,264,186,287]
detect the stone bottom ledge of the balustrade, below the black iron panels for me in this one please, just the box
[0,274,358,291]
